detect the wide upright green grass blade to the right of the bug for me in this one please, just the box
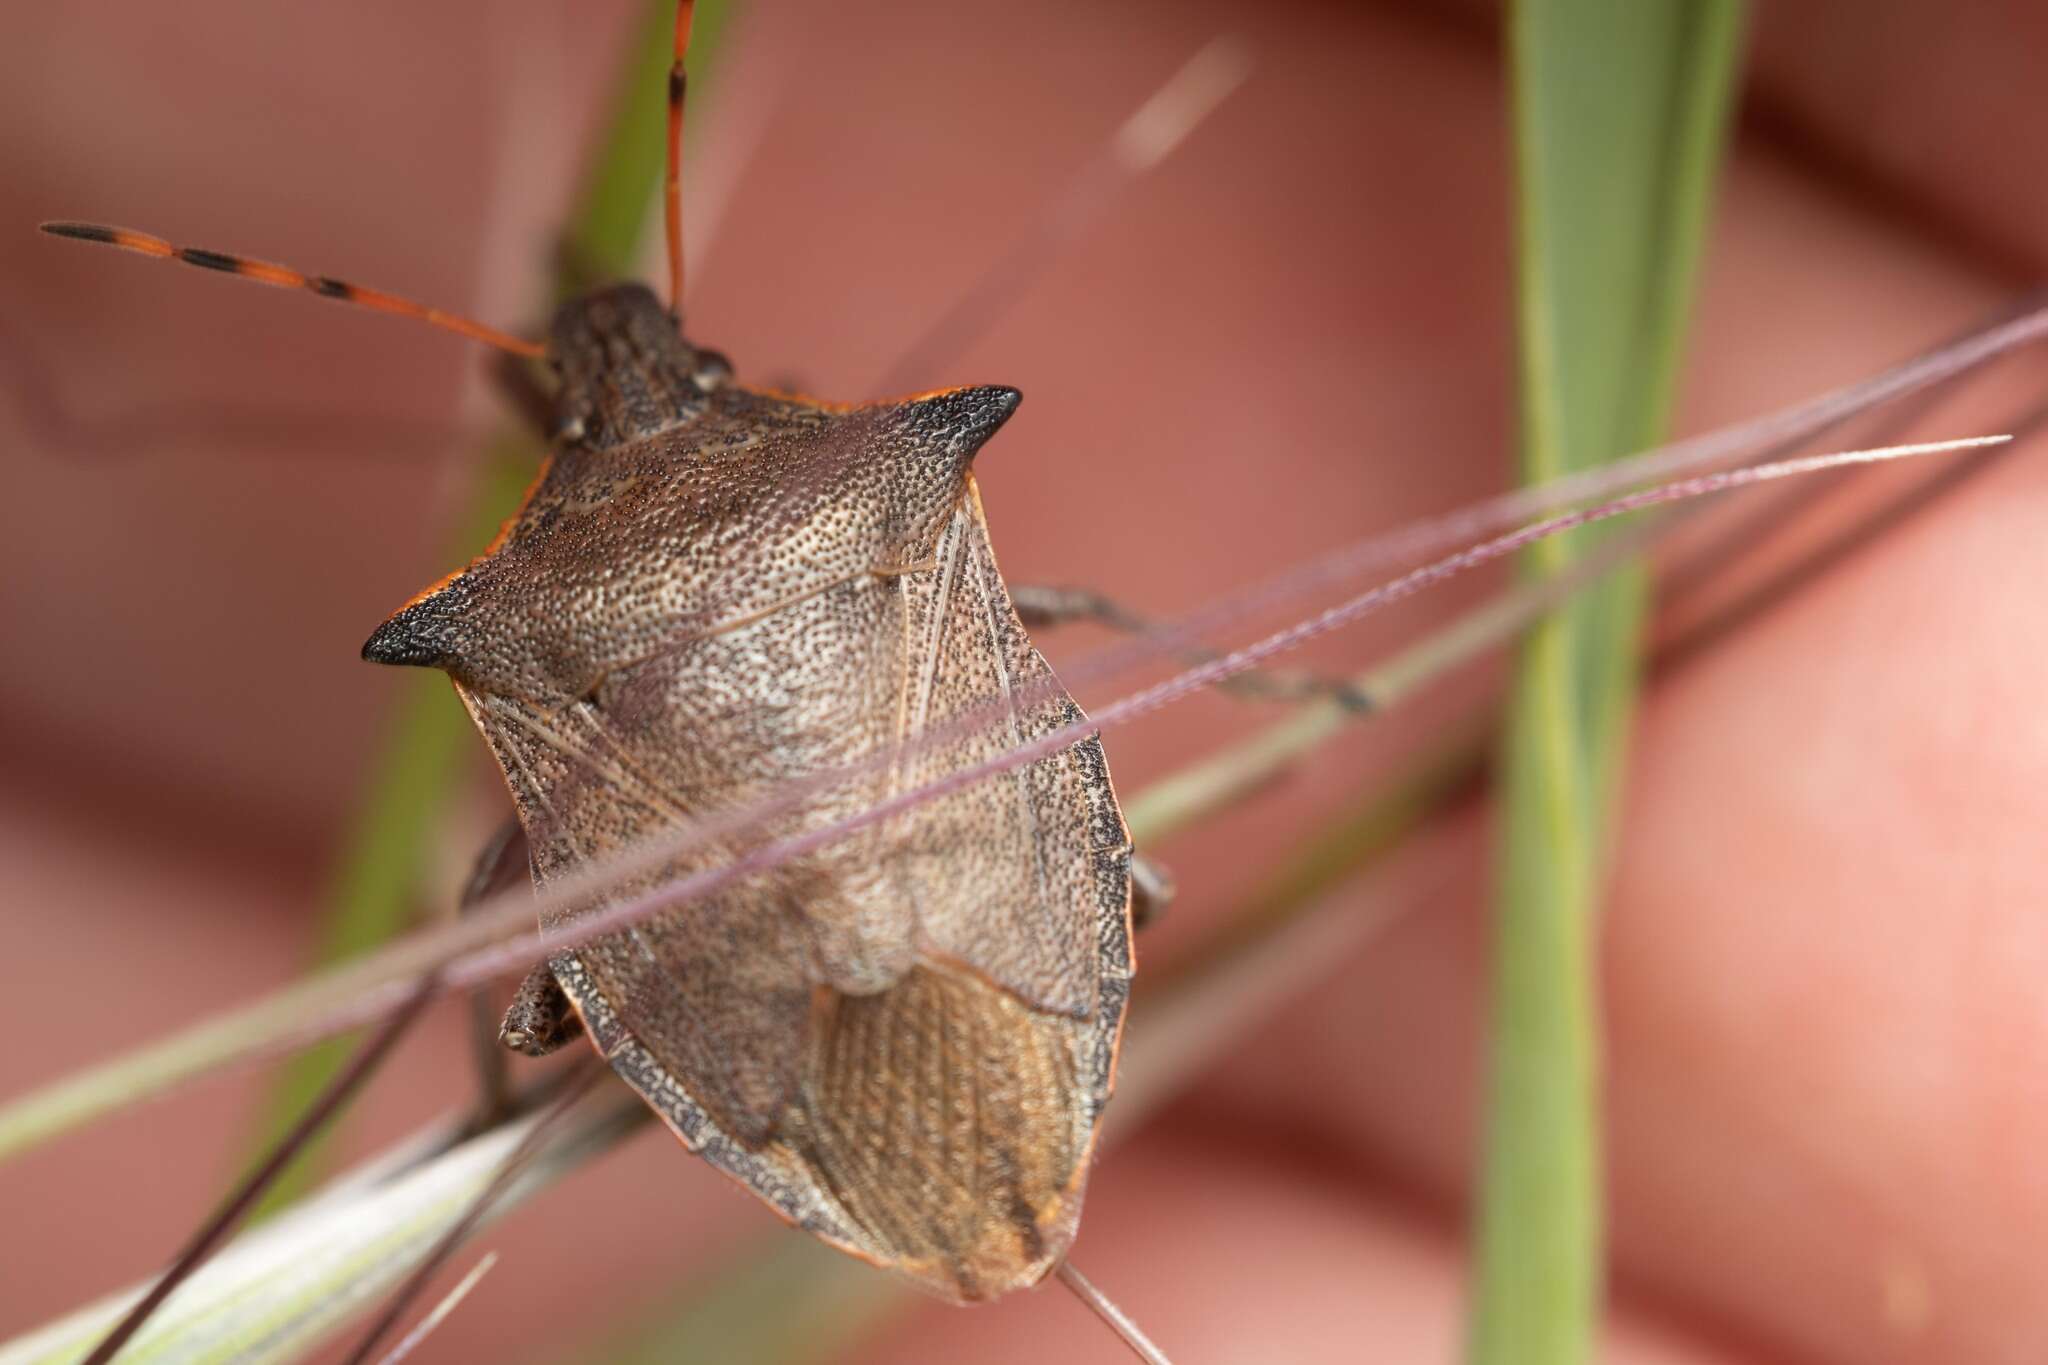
[1470,0,1743,1365]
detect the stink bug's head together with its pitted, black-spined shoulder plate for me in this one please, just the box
[362,296,1020,708]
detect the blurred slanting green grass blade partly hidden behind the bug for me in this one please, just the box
[246,0,733,1212]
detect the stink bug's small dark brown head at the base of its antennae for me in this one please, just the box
[547,284,733,448]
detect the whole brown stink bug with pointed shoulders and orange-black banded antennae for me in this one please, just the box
[45,0,1133,1302]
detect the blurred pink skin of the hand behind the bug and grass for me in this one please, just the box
[0,0,2048,1363]
